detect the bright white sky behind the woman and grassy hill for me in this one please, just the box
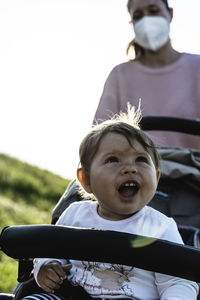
[0,0,200,178]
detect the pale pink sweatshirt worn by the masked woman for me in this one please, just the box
[95,53,200,149]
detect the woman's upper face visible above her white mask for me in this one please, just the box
[130,0,171,24]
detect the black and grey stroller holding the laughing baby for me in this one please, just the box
[0,116,200,300]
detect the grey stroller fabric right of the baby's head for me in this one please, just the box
[149,148,200,228]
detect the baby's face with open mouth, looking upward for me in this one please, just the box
[87,133,160,220]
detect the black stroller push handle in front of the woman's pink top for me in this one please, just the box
[140,116,200,135]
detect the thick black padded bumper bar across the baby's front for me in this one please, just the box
[0,225,200,282]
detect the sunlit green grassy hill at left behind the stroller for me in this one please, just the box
[0,154,69,293]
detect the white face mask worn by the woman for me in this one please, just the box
[134,16,169,51]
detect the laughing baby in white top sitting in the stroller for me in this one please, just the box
[34,106,198,300]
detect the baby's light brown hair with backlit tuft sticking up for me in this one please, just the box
[79,104,160,173]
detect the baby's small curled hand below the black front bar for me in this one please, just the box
[37,260,72,293]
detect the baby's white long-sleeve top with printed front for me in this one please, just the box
[34,201,198,300]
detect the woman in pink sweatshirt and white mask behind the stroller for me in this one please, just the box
[94,0,200,149]
